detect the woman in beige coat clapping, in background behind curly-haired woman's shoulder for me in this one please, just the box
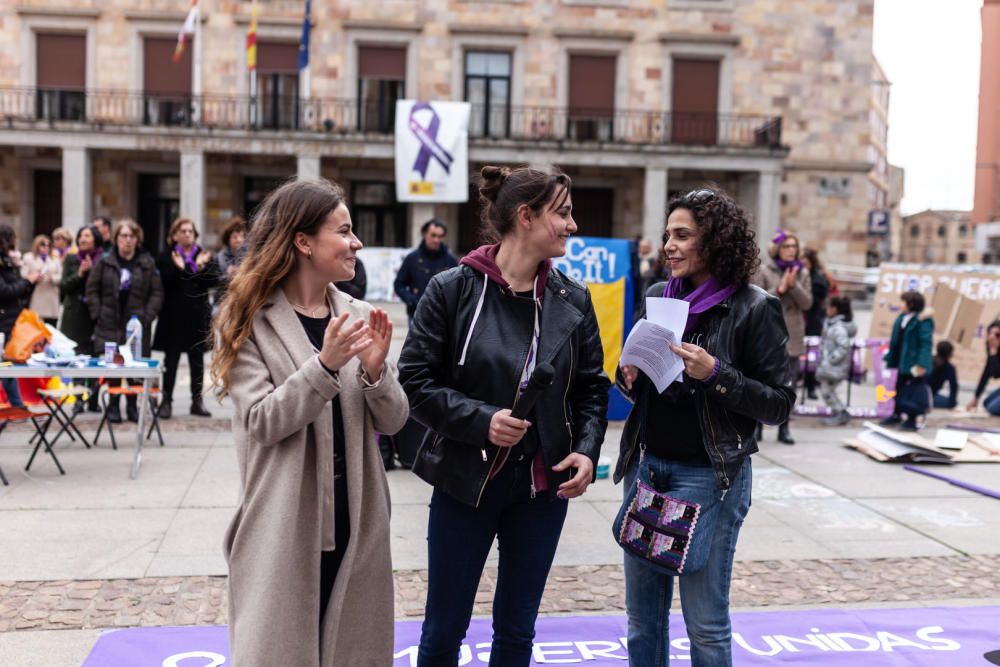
[754,229,812,445]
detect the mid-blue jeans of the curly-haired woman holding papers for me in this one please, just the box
[625,454,752,667]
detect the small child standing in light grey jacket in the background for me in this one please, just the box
[816,296,858,426]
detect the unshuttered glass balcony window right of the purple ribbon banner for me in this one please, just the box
[465,51,510,137]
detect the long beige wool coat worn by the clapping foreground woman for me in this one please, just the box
[224,285,409,667]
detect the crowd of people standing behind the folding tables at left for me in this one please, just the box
[0,216,254,423]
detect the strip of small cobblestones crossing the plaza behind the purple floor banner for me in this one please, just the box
[0,555,1000,632]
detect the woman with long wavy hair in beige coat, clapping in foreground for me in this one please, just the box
[212,180,409,667]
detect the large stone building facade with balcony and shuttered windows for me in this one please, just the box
[0,0,885,265]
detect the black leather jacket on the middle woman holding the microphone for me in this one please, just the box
[399,265,611,506]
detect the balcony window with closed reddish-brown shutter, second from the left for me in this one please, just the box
[142,35,194,125]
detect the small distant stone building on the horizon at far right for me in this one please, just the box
[899,210,981,265]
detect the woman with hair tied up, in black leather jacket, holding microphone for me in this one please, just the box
[399,167,610,667]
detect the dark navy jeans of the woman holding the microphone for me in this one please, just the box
[417,463,568,667]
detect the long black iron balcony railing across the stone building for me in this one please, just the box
[0,88,781,148]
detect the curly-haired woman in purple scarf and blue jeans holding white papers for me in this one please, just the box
[614,189,795,667]
